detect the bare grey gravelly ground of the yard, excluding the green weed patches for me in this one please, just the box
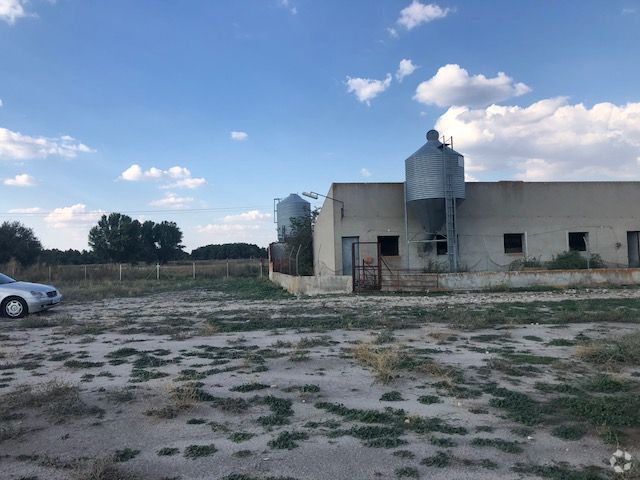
[0,289,640,480]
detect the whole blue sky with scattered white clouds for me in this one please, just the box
[0,0,640,251]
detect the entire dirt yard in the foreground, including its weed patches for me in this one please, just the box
[0,282,640,480]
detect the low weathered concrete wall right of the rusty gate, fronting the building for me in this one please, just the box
[438,268,640,290]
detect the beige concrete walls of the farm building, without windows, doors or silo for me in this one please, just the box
[314,182,640,275]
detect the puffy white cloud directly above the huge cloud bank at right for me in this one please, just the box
[414,64,531,107]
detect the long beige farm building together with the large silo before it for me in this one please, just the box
[313,131,640,284]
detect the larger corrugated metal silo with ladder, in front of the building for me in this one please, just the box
[405,130,465,272]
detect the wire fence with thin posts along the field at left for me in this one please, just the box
[0,259,269,282]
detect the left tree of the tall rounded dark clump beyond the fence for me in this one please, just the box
[89,213,141,262]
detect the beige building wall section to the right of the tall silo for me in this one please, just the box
[458,182,640,271]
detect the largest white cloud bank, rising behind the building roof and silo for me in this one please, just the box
[436,97,640,180]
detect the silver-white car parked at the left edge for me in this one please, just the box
[0,273,62,318]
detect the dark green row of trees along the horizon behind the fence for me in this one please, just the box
[0,219,267,265]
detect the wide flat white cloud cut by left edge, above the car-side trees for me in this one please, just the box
[0,127,95,160]
